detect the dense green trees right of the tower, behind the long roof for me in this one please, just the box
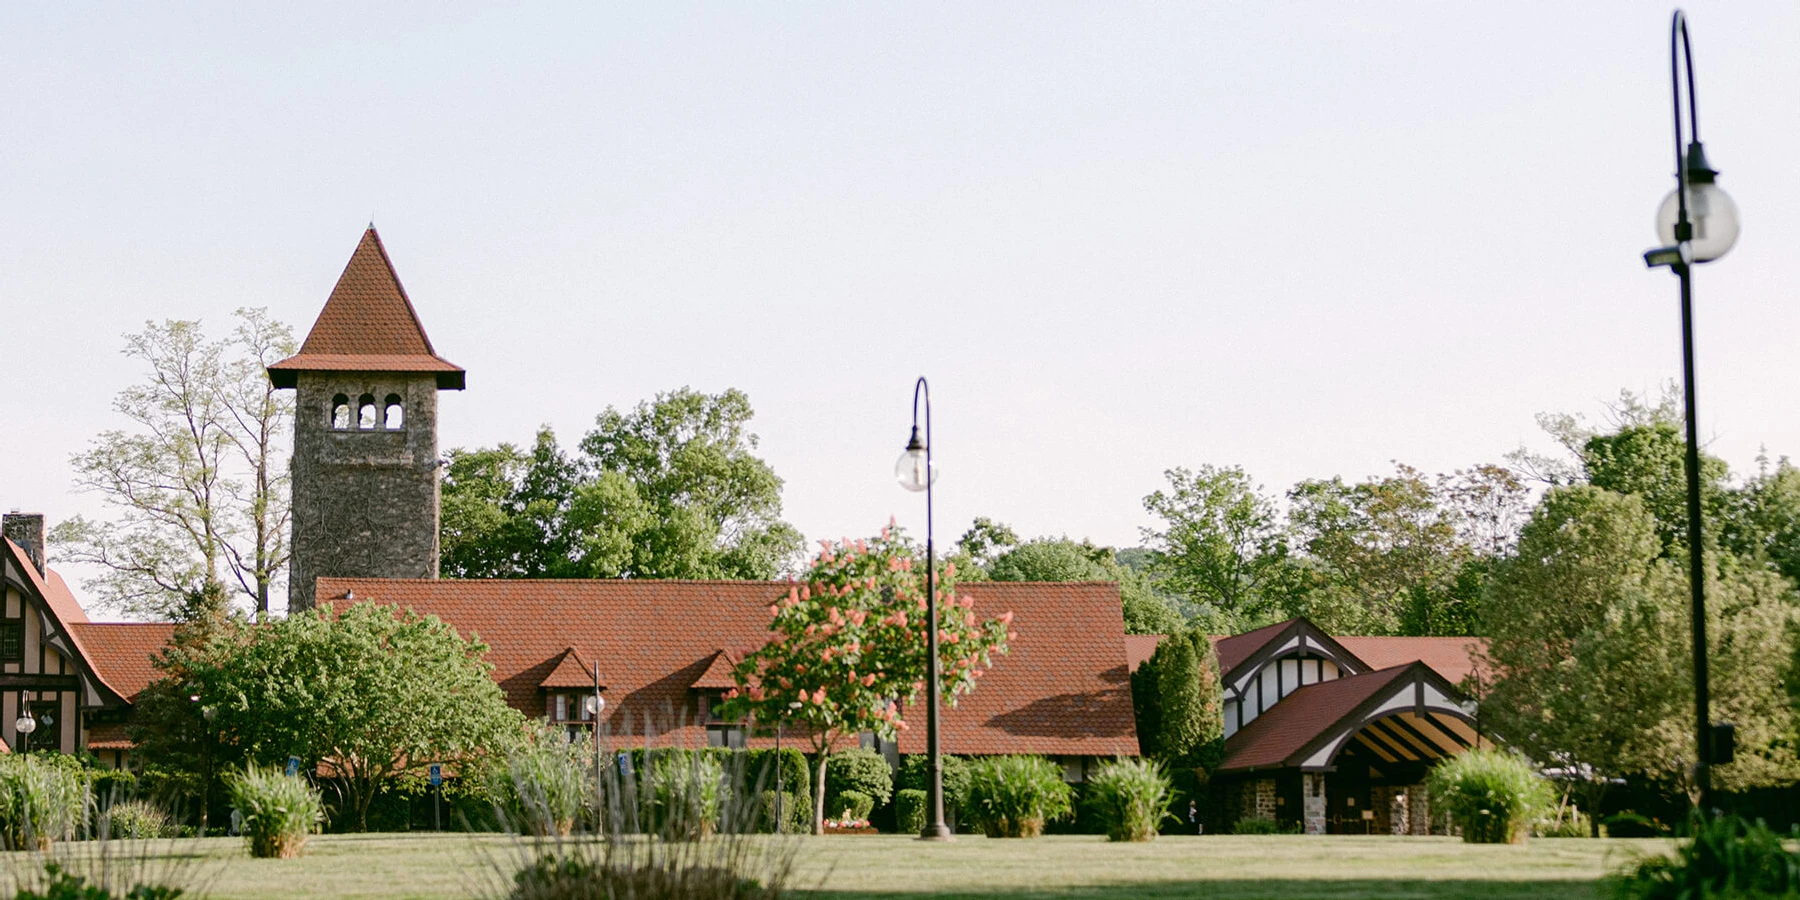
[443,387,801,580]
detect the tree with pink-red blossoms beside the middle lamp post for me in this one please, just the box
[724,524,1013,833]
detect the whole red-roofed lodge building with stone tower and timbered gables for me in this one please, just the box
[10,227,1487,833]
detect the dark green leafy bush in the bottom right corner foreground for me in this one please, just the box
[1606,815,1800,900]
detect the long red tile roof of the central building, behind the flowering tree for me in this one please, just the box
[317,578,1138,756]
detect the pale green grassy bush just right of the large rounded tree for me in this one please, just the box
[490,725,594,837]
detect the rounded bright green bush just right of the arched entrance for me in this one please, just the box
[1426,751,1552,844]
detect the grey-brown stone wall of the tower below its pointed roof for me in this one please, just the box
[288,373,439,612]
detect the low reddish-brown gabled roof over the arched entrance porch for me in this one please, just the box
[1219,662,1465,772]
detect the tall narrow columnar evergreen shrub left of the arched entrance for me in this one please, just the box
[1147,632,1224,770]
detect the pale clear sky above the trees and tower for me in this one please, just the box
[0,2,1800,615]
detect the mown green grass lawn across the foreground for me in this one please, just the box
[5,835,1669,900]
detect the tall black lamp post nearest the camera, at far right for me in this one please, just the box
[1643,9,1737,824]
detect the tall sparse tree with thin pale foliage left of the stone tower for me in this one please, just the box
[50,310,293,617]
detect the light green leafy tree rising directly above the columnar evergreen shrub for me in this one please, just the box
[1143,466,1287,623]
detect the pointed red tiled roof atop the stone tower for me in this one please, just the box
[268,225,463,391]
